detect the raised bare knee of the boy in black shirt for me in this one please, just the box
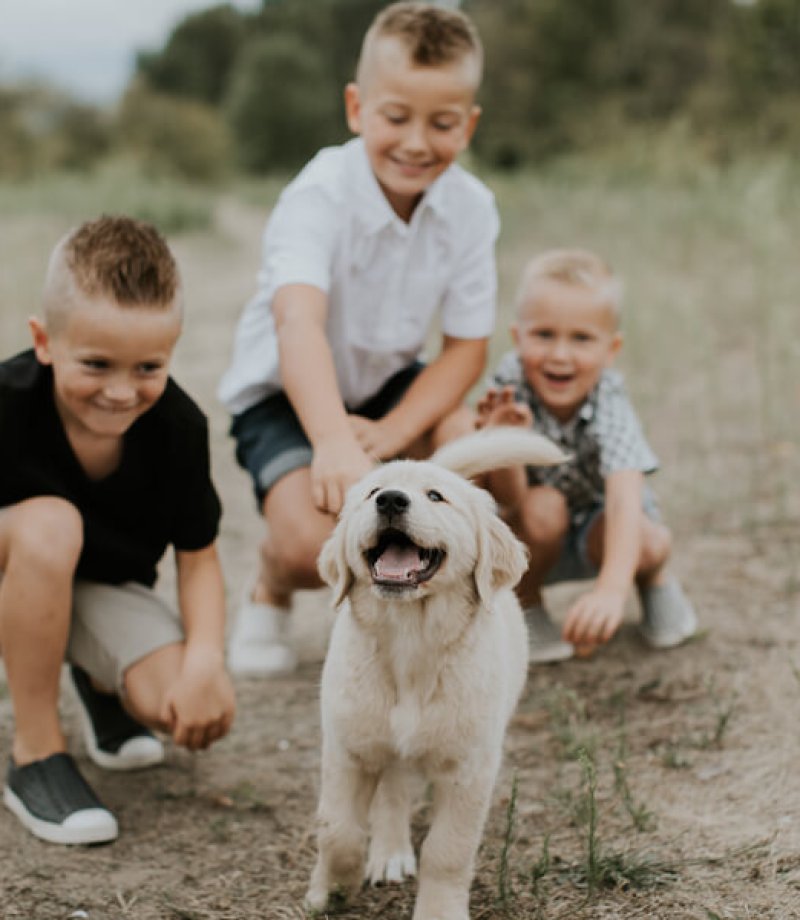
[8,496,83,577]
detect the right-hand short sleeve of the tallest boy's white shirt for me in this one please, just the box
[442,192,500,339]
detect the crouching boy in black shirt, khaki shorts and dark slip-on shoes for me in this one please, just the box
[0,217,235,844]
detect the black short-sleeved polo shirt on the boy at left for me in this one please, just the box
[0,350,221,586]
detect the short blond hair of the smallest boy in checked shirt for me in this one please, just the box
[516,249,622,323]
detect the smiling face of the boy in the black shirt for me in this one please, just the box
[31,298,181,440]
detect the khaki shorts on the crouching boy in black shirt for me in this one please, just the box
[65,580,184,692]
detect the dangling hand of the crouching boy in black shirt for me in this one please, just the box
[162,649,236,751]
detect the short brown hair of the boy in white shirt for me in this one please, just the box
[356,2,483,87]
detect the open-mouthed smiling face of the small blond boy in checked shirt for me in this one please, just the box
[511,278,622,422]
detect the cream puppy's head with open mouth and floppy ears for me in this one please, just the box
[319,460,526,625]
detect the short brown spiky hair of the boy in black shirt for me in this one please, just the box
[42,215,181,325]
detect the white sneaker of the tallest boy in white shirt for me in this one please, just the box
[228,600,297,677]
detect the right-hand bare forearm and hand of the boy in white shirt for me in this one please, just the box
[354,336,488,460]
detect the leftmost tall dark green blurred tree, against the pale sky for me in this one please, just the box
[136,4,247,105]
